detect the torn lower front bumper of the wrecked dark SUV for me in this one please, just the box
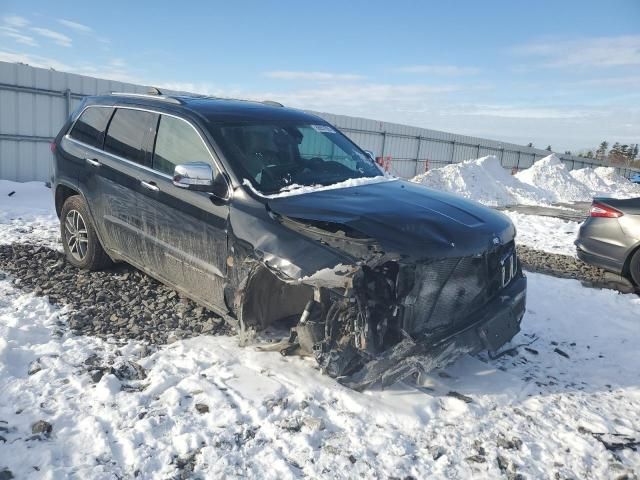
[338,275,527,391]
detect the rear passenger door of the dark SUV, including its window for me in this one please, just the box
[84,107,158,265]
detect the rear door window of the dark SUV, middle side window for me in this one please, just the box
[104,108,158,167]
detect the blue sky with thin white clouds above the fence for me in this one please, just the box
[0,0,640,151]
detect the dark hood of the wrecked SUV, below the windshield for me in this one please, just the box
[268,180,515,258]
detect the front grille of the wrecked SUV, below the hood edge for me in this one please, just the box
[401,242,518,334]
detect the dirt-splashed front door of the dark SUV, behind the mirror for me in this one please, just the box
[139,114,229,313]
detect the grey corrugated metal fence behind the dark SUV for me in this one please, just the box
[0,58,632,181]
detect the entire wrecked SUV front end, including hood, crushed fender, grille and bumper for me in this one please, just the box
[231,181,526,390]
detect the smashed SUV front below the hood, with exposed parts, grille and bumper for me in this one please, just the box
[238,210,526,390]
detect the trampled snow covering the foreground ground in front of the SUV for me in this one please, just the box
[0,268,640,479]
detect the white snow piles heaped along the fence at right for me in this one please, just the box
[411,154,640,207]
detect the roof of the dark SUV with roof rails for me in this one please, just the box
[86,93,326,124]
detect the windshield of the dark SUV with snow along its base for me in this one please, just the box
[210,122,382,195]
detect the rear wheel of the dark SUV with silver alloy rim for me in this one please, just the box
[60,195,112,270]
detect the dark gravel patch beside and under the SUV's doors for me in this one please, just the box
[0,244,232,345]
